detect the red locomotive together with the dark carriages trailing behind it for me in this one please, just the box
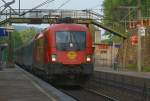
[16,19,93,83]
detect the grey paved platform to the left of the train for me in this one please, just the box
[0,66,75,101]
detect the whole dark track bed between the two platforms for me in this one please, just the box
[17,65,149,101]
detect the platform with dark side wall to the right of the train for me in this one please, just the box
[93,67,150,96]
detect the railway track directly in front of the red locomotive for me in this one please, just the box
[57,87,119,101]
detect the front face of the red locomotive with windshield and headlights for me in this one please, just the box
[50,24,93,75]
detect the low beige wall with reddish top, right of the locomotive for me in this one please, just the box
[95,44,120,67]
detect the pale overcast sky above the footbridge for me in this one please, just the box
[0,0,103,9]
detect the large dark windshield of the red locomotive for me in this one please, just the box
[56,31,86,50]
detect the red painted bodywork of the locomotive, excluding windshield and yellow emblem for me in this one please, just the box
[34,24,93,65]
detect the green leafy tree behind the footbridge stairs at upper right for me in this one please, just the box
[103,0,150,42]
